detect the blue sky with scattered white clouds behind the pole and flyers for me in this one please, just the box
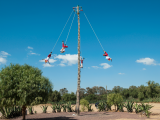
[0,0,160,92]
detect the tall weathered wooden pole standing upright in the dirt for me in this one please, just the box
[76,6,81,115]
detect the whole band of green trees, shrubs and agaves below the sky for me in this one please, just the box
[0,64,160,119]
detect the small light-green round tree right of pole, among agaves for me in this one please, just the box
[107,93,123,110]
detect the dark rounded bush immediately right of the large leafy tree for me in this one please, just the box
[48,90,61,102]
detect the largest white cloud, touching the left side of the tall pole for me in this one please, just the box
[54,54,78,66]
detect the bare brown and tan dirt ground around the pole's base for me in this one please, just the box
[0,103,160,120]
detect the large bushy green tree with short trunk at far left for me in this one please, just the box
[0,64,52,120]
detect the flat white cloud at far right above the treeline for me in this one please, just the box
[136,58,156,65]
